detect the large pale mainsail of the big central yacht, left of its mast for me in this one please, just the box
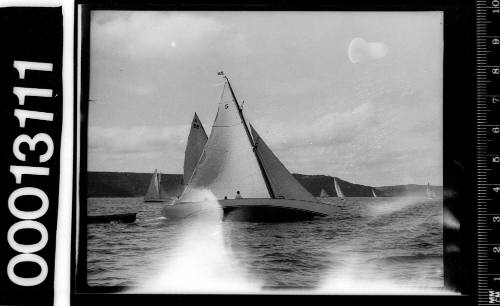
[180,82,271,202]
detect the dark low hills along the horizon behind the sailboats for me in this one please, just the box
[87,172,442,197]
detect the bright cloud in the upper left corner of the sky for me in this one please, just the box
[91,12,223,59]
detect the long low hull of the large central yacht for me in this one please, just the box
[162,199,337,222]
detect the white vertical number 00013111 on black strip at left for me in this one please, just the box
[7,61,54,286]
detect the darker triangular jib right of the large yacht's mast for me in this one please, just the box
[250,125,316,202]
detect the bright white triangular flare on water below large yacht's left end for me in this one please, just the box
[128,191,261,294]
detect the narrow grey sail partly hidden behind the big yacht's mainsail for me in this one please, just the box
[184,113,208,185]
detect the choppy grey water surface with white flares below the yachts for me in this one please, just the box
[87,197,450,294]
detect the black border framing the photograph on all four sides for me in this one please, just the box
[70,0,477,305]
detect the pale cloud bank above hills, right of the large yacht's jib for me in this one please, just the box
[248,102,442,186]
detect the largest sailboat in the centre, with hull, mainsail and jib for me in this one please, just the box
[162,73,335,221]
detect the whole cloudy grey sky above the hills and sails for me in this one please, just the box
[88,11,443,186]
